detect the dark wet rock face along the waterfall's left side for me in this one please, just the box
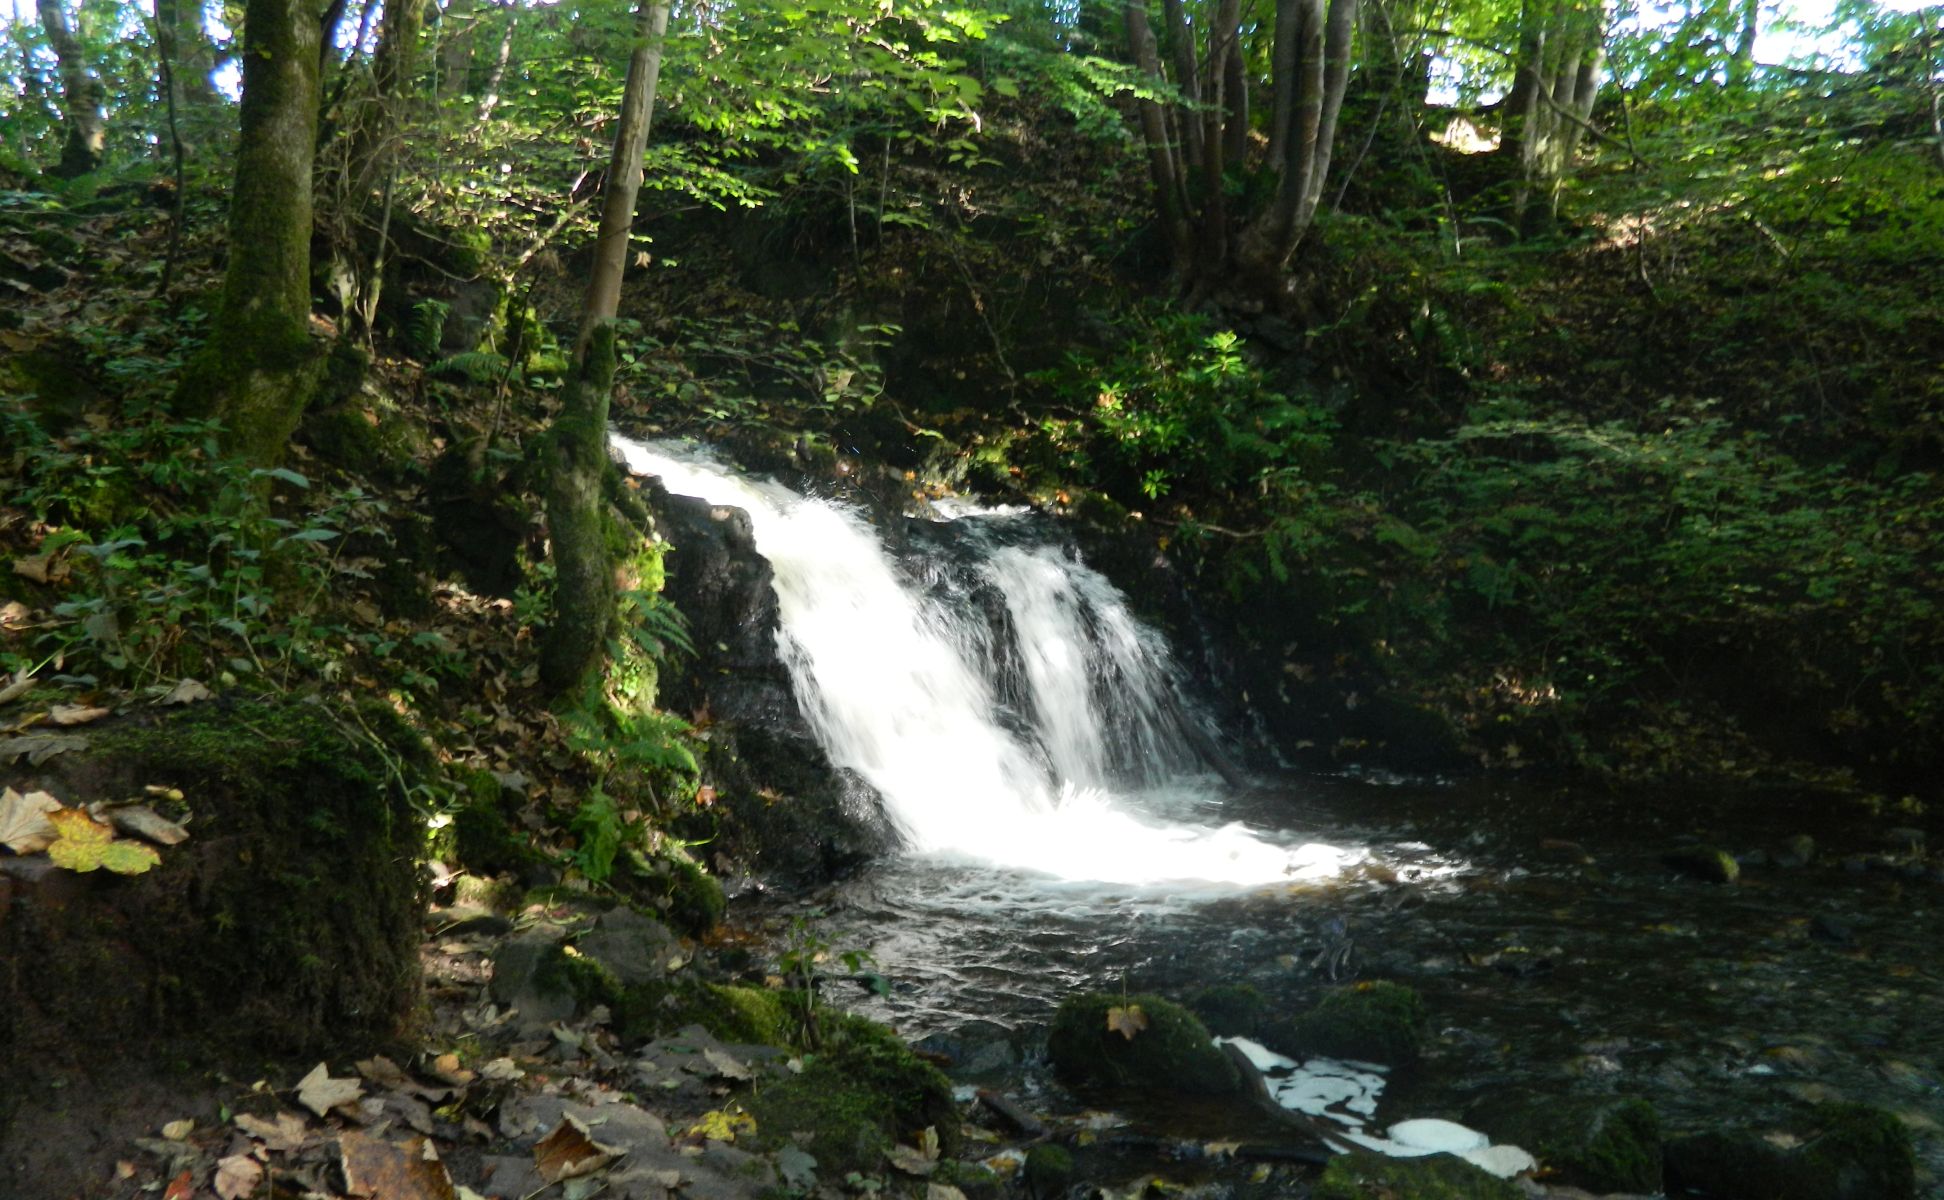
[649,486,892,885]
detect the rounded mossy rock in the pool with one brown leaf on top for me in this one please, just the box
[1046,992,1236,1095]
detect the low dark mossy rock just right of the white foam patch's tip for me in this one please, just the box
[1466,1095,1660,1194]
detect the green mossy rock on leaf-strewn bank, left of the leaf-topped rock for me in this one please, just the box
[748,1031,962,1177]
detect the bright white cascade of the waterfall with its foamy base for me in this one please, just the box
[612,436,1345,885]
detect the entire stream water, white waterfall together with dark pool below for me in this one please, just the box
[616,438,1944,1188]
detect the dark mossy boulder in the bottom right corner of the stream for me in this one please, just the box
[1666,1105,1917,1200]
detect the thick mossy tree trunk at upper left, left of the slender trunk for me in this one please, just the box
[177,0,323,467]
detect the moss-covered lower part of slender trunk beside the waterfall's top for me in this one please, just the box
[540,321,614,696]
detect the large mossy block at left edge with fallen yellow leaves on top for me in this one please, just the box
[0,702,424,1126]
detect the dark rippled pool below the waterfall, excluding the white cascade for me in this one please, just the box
[793,778,1944,1188]
